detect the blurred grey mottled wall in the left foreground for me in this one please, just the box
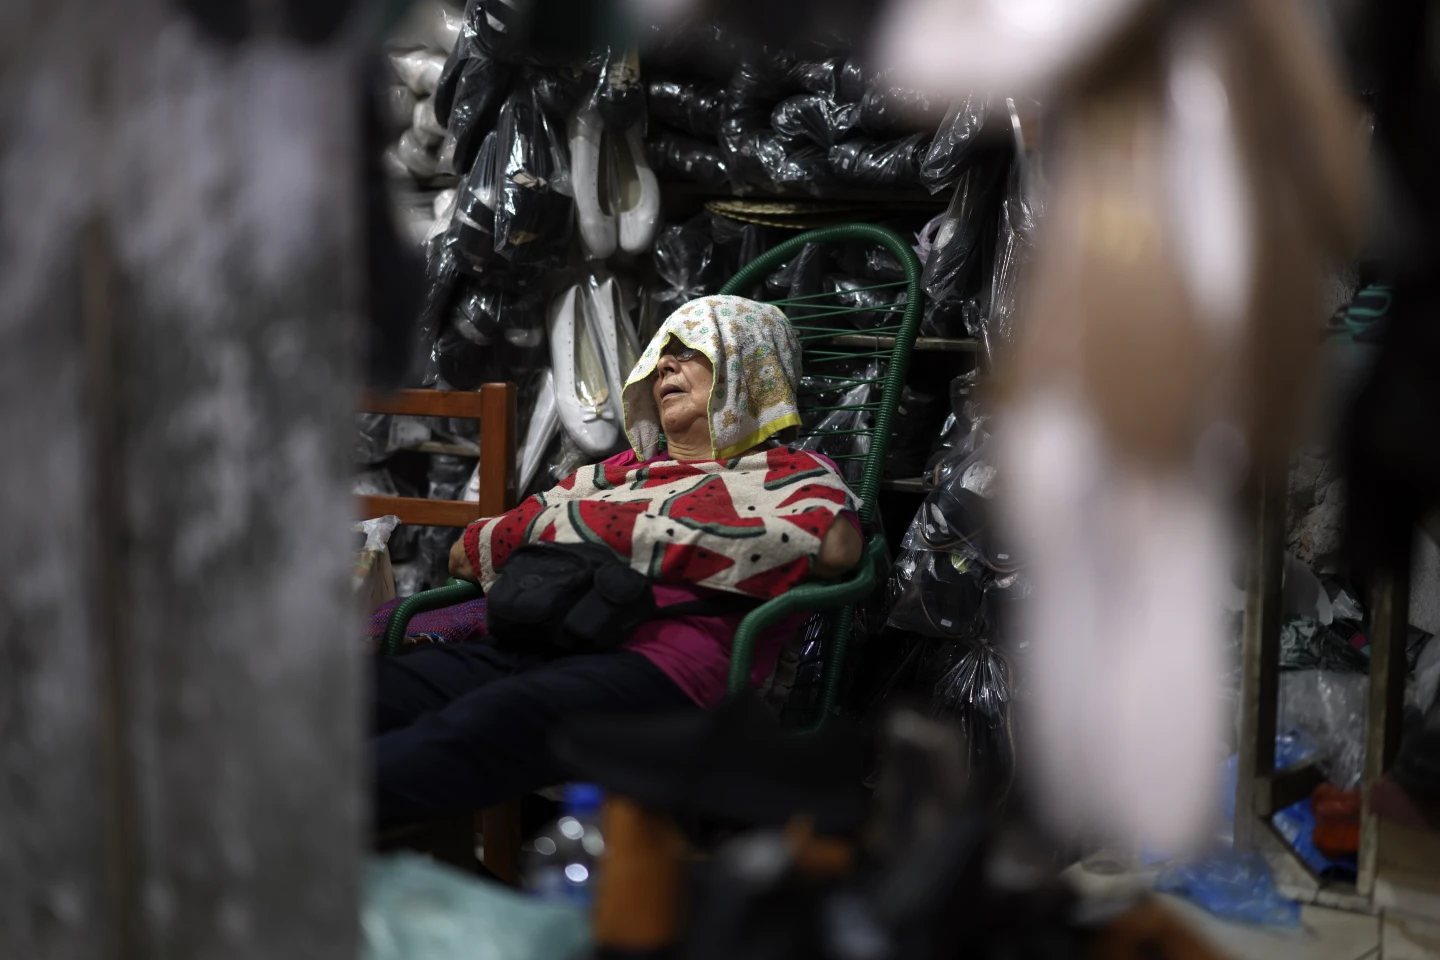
[0,0,363,960]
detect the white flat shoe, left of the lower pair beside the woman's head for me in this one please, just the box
[549,286,621,456]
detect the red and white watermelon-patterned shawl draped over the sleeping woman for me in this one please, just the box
[465,446,858,600]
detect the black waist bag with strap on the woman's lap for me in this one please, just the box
[485,543,756,653]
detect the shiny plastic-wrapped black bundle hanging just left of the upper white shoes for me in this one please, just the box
[494,86,575,263]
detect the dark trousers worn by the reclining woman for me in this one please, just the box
[370,642,698,828]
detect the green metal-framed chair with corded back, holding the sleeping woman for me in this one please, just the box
[382,223,923,731]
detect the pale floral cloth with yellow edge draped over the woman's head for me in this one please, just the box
[622,295,801,461]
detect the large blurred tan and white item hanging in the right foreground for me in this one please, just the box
[881,0,1364,851]
